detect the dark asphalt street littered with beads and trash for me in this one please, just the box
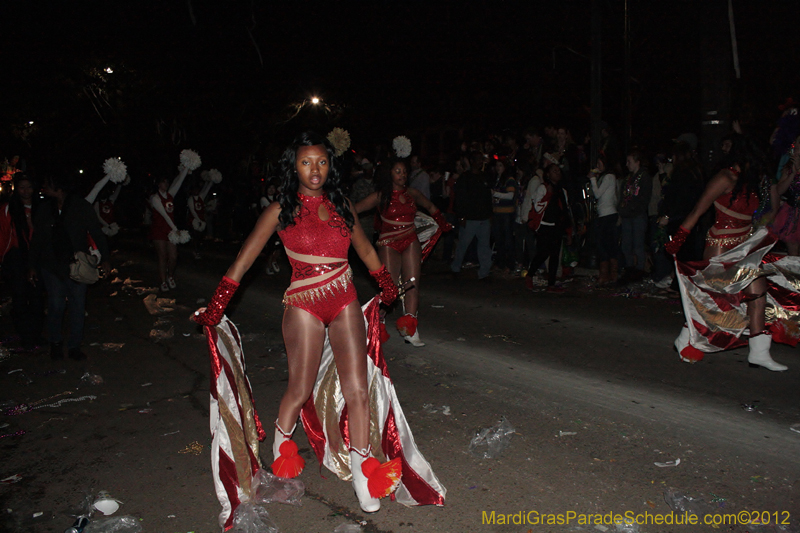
[0,239,800,533]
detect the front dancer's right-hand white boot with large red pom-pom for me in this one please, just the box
[350,446,403,513]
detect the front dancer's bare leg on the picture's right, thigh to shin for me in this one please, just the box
[326,301,369,450]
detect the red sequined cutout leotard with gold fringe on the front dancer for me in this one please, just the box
[278,193,357,326]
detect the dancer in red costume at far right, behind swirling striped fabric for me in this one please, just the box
[665,142,787,371]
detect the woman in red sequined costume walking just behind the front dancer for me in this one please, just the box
[356,159,451,346]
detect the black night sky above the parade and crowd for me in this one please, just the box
[0,0,800,179]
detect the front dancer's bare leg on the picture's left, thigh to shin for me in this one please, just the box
[278,306,325,431]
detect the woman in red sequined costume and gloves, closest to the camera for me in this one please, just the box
[193,133,398,512]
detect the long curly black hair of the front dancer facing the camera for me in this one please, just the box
[278,131,355,230]
